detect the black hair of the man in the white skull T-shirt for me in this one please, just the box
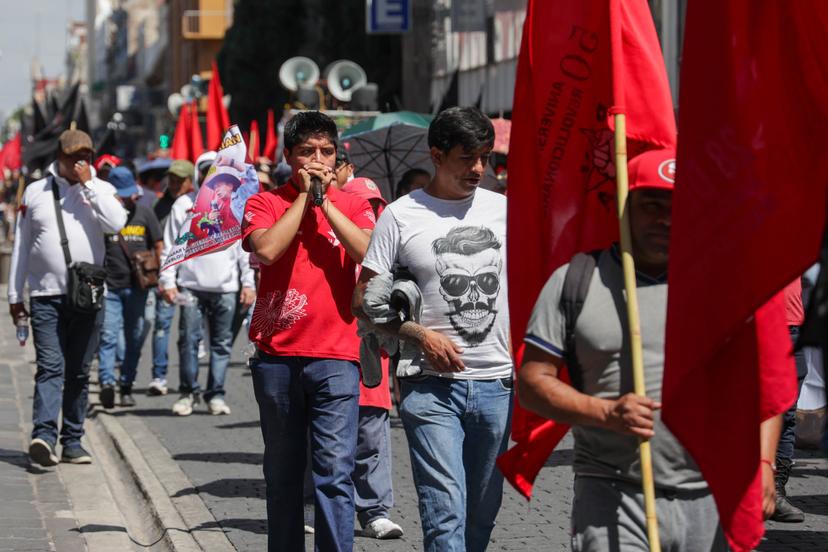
[428,107,494,152]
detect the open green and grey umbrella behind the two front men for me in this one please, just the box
[341,111,433,201]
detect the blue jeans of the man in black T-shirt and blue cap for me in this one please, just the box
[98,288,147,388]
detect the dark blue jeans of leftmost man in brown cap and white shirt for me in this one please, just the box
[31,295,104,447]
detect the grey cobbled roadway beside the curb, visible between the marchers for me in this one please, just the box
[112,310,828,552]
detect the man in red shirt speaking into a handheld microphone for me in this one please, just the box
[242,111,375,551]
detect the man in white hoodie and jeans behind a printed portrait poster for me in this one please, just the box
[159,154,256,416]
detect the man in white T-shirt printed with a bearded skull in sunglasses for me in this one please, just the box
[353,108,512,552]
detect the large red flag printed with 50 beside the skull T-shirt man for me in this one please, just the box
[498,0,676,497]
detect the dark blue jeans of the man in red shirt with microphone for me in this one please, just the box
[250,351,359,552]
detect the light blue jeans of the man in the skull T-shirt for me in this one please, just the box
[400,376,512,552]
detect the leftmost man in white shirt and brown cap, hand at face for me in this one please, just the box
[9,130,127,466]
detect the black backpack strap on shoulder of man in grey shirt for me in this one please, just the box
[559,251,601,391]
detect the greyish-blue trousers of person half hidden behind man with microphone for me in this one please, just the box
[352,406,394,528]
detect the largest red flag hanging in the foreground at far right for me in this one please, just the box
[662,0,828,551]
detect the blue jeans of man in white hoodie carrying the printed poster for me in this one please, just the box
[178,290,236,401]
